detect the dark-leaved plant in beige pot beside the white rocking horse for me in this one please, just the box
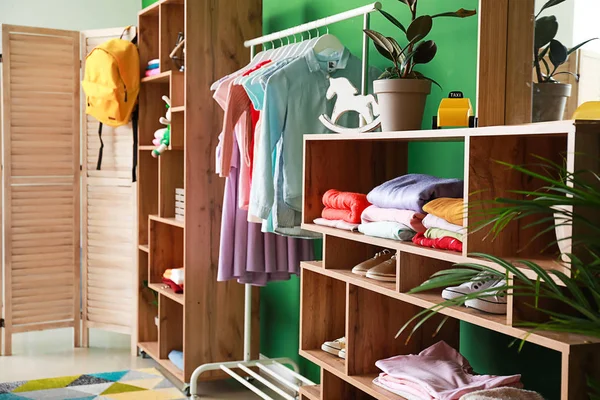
[365,0,476,131]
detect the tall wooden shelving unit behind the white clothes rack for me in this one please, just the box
[137,0,261,382]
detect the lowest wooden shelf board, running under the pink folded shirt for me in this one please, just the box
[300,350,405,400]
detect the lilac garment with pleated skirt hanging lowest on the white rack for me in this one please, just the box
[217,136,314,286]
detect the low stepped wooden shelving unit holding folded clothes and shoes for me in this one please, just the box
[300,121,600,400]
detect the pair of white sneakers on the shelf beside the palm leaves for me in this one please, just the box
[442,273,506,314]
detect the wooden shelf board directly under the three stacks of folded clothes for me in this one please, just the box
[302,224,568,286]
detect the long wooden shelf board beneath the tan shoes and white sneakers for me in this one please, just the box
[301,261,600,351]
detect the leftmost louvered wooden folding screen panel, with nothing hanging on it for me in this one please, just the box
[2,25,80,355]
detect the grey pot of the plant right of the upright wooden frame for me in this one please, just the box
[532,83,571,122]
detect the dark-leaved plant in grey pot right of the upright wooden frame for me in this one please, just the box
[532,0,597,122]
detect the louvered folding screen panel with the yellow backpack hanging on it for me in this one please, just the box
[82,29,137,346]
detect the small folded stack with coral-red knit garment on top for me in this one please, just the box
[313,189,370,231]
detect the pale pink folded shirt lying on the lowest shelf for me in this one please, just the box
[375,341,522,400]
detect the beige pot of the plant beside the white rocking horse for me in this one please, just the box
[373,79,431,132]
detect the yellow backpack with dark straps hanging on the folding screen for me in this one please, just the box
[81,26,140,182]
